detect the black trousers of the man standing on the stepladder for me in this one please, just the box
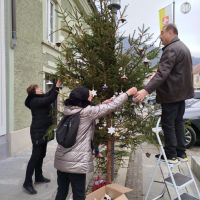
[161,101,186,158]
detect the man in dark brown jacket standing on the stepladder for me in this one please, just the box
[136,24,194,164]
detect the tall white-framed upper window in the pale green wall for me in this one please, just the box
[47,0,56,43]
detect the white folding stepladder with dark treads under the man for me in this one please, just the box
[145,118,200,200]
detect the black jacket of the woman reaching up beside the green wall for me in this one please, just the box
[25,85,59,144]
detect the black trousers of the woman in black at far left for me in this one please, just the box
[24,142,47,185]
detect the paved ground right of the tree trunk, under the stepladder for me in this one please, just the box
[126,143,200,200]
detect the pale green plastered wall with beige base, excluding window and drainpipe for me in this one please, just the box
[7,0,93,155]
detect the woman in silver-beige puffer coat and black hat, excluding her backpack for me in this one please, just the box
[54,87,137,200]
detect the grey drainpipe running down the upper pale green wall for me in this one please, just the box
[11,0,17,49]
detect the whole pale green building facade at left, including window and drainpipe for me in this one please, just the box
[0,0,92,159]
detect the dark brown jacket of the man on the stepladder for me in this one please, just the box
[145,37,194,103]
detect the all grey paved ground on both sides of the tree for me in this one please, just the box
[0,141,200,200]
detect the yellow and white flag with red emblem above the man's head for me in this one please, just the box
[159,4,173,30]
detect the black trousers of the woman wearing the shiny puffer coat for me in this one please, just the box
[55,170,86,200]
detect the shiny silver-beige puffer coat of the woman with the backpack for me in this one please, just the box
[54,93,128,174]
